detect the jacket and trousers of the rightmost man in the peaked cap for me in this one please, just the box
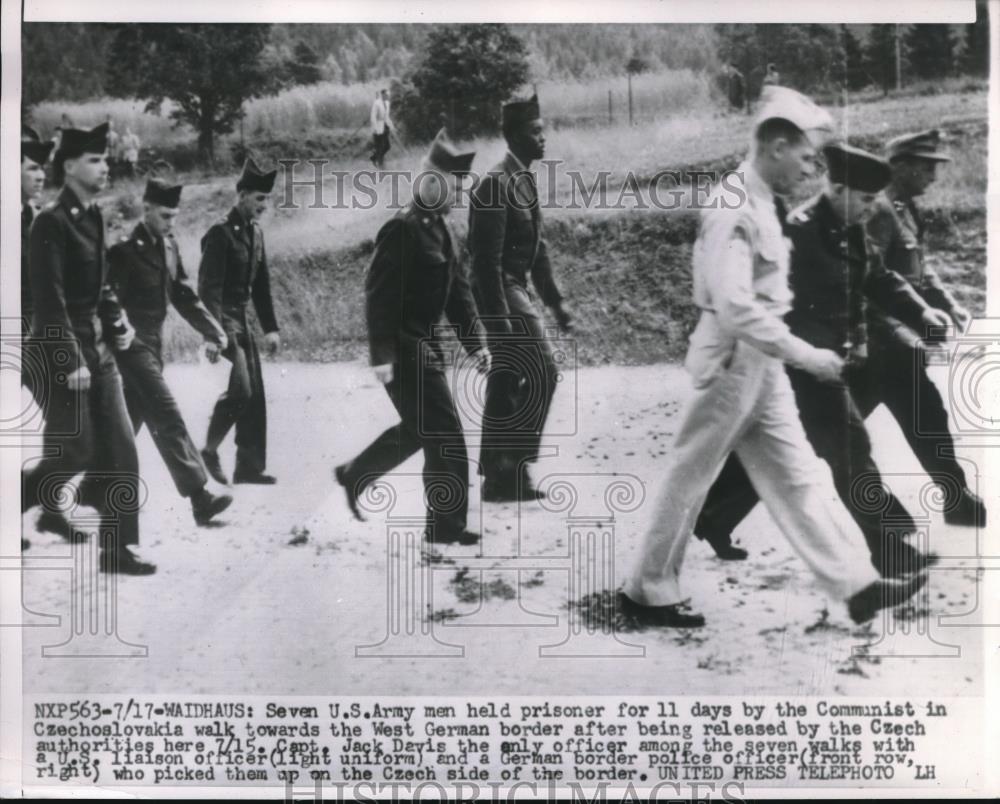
[855,195,967,496]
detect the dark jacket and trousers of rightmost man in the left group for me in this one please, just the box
[198,207,278,474]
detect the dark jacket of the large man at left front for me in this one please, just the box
[29,186,122,373]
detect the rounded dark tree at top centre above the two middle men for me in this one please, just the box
[393,23,528,139]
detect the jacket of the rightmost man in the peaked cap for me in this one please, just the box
[867,191,957,343]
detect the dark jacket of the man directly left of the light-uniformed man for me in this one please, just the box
[469,154,562,326]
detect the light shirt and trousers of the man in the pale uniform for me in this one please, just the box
[625,162,878,606]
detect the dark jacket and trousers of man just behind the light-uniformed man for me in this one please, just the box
[695,197,925,569]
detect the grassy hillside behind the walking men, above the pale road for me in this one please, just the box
[99,92,987,364]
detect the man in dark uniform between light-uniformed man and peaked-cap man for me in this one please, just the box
[695,145,943,575]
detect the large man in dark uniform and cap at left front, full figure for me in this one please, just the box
[22,124,156,575]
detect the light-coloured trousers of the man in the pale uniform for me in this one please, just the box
[625,342,878,606]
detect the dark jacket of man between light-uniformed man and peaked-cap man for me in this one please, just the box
[785,195,927,355]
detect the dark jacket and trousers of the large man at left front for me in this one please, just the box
[21,188,142,545]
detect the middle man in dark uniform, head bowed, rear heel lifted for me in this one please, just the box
[334,131,490,544]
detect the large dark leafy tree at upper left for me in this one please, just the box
[108,23,276,161]
